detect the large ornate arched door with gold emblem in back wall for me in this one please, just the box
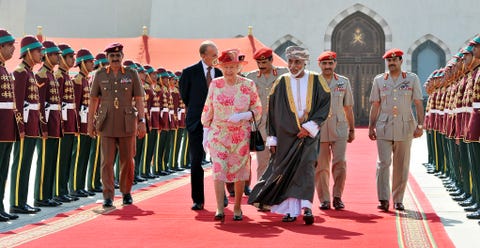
[332,12,385,126]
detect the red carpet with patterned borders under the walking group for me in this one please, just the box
[0,129,454,247]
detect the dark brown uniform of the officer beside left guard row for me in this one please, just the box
[90,67,145,199]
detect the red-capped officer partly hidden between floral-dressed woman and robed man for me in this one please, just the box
[245,47,288,179]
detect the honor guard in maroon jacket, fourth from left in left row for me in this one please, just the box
[54,44,80,202]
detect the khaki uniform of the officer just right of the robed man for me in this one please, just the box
[315,74,353,202]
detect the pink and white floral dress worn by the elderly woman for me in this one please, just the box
[202,76,262,182]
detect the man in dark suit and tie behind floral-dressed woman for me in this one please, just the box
[179,41,222,210]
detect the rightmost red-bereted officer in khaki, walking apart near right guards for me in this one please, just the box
[368,48,424,211]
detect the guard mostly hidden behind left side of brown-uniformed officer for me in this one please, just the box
[87,52,109,192]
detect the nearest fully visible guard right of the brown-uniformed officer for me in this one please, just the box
[140,65,160,179]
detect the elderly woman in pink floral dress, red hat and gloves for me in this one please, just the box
[202,49,262,222]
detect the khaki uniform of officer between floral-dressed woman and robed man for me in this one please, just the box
[245,67,288,179]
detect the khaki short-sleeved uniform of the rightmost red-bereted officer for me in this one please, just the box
[370,72,422,203]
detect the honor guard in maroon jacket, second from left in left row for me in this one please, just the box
[10,35,47,214]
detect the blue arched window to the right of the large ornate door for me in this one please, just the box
[412,40,445,95]
